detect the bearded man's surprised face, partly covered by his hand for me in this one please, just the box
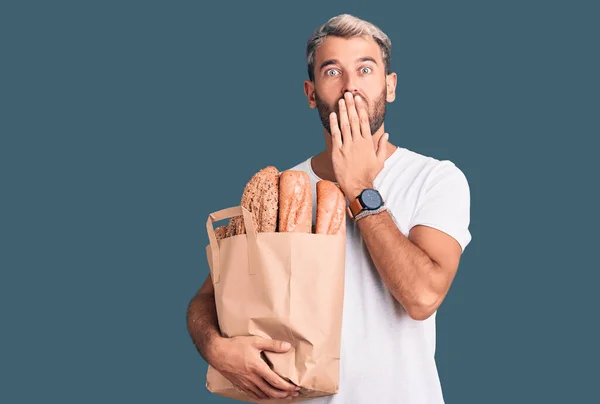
[309,37,393,134]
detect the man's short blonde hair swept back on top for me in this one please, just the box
[306,14,392,81]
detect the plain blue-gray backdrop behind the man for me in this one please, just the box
[0,0,600,404]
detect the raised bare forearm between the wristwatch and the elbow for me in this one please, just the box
[357,211,442,319]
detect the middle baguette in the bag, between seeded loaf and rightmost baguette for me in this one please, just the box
[277,170,312,233]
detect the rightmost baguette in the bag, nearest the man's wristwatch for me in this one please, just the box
[315,180,346,235]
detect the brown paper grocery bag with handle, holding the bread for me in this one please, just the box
[206,206,346,403]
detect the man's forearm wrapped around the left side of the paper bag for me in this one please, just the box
[187,292,222,364]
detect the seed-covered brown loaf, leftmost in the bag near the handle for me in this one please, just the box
[226,166,279,237]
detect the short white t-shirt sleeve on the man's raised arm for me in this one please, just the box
[409,160,471,251]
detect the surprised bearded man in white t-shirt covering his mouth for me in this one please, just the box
[188,15,471,404]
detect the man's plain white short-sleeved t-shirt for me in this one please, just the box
[284,147,471,404]
